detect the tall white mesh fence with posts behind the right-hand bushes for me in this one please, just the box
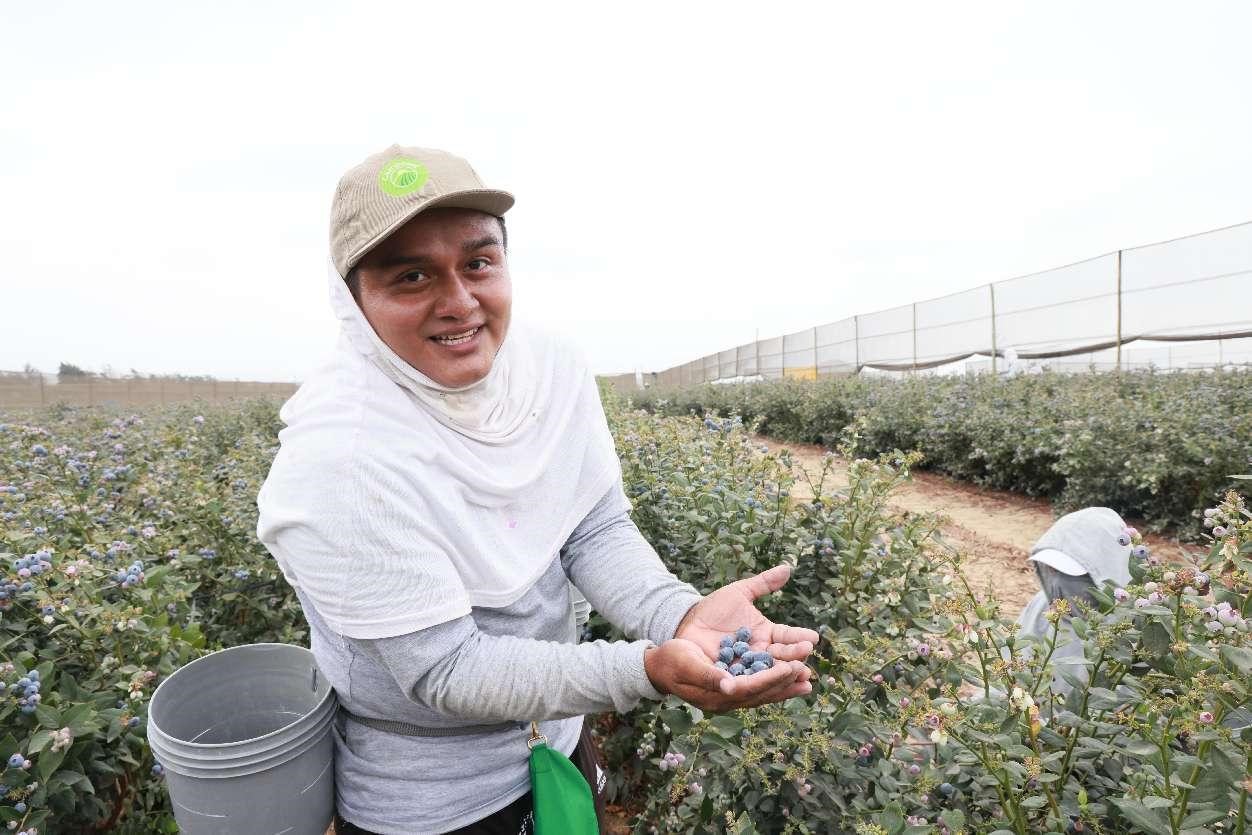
[646,223,1252,386]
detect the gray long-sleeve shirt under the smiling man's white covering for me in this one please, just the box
[297,483,700,835]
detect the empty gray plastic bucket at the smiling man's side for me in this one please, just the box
[148,643,338,835]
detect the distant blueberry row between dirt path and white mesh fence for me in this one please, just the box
[634,372,1252,537]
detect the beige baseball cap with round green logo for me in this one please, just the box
[331,145,513,277]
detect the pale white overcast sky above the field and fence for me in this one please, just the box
[0,0,1252,381]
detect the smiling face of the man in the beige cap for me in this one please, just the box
[356,208,513,388]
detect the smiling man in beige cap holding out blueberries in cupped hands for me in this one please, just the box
[258,145,818,835]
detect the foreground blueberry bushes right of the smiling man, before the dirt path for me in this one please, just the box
[597,395,1252,835]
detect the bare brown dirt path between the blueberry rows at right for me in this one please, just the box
[757,437,1198,608]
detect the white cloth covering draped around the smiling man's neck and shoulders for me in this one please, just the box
[257,267,621,638]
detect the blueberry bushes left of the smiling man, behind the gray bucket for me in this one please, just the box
[0,402,307,834]
